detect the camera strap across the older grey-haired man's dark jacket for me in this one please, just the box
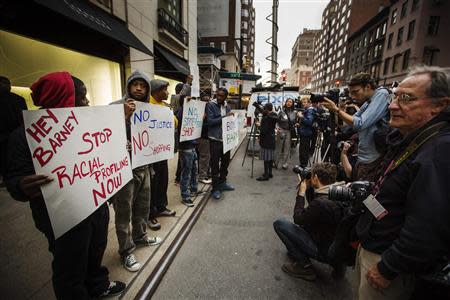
[373,121,448,197]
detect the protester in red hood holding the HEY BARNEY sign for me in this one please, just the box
[6,72,125,299]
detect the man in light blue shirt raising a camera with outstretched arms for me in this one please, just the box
[322,73,390,181]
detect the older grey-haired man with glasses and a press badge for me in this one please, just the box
[356,66,450,299]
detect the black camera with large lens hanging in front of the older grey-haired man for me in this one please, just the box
[328,181,373,210]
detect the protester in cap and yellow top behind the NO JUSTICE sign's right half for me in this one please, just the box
[149,79,178,223]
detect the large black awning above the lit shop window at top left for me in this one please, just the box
[34,0,153,56]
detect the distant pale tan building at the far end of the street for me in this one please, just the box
[291,28,320,90]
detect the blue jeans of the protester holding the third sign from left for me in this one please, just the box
[178,149,198,199]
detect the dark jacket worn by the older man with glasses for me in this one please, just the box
[356,111,450,279]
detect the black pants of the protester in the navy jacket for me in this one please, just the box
[209,140,230,190]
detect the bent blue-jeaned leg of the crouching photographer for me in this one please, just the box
[273,219,326,266]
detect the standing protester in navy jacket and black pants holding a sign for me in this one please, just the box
[206,88,234,199]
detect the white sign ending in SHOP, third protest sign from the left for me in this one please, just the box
[180,99,206,142]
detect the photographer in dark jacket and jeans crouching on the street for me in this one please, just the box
[273,163,345,281]
